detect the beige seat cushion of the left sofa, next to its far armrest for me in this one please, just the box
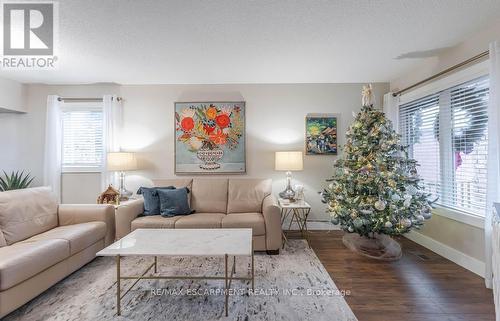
[25,222,106,255]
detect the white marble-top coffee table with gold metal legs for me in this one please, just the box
[96,229,254,316]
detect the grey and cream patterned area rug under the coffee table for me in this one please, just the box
[5,240,356,321]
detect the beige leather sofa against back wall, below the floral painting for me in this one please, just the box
[115,178,281,254]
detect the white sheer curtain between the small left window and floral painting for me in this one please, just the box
[101,95,123,190]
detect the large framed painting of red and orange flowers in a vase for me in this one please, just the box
[175,101,246,174]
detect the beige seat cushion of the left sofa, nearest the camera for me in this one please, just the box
[0,239,70,291]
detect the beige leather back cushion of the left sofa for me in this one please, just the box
[0,187,58,245]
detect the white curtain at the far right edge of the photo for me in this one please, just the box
[484,41,500,288]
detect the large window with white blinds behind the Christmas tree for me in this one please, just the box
[399,76,489,215]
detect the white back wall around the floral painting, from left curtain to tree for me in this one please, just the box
[121,84,388,219]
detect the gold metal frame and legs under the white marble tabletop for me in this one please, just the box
[116,246,255,317]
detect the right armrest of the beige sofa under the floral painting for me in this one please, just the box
[262,194,282,251]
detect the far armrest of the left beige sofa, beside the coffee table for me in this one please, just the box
[58,204,115,246]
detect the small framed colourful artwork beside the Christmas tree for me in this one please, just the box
[306,114,338,155]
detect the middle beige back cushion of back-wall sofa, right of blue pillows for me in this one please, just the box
[191,178,227,213]
